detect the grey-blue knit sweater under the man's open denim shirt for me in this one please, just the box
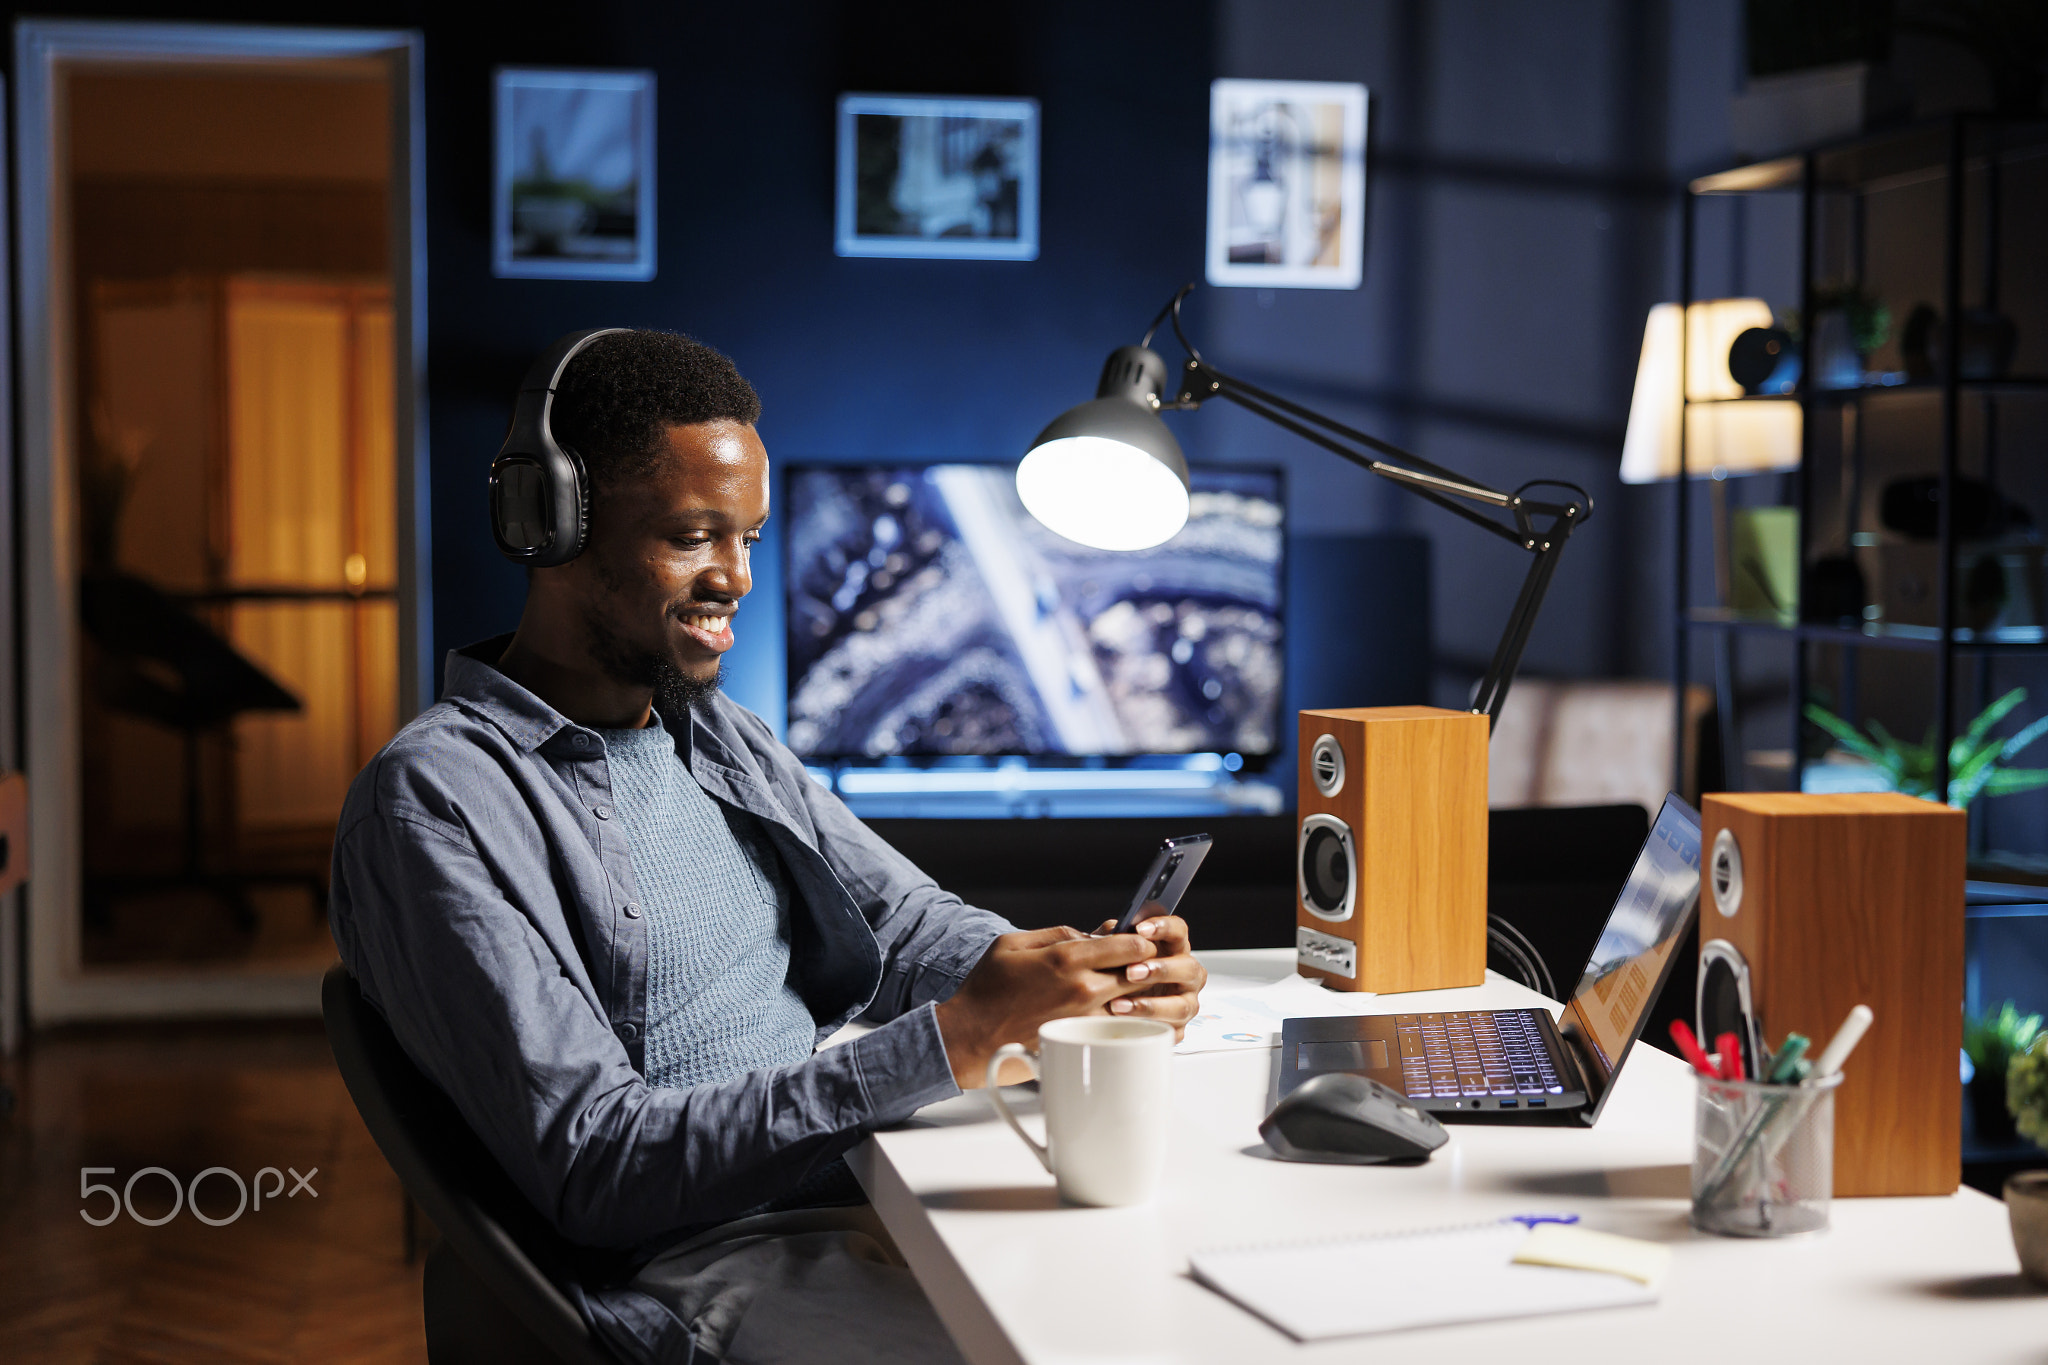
[600,716,817,1089]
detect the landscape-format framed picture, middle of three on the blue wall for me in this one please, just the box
[836,94,1038,260]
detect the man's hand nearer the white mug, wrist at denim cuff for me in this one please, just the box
[938,927,1159,1091]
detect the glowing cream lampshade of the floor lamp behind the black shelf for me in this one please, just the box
[1622,299,1800,483]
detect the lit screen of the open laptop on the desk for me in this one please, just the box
[1561,796,1700,1101]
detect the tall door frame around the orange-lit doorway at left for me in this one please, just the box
[14,18,432,1027]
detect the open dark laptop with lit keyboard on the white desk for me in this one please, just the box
[1280,796,1700,1124]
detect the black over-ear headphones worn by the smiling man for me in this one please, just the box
[492,327,625,569]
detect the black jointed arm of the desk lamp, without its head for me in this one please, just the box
[1141,284,1593,731]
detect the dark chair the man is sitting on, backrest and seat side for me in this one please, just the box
[319,966,618,1365]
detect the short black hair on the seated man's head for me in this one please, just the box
[549,332,762,493]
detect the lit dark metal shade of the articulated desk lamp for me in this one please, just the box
[1018,346,1188,551]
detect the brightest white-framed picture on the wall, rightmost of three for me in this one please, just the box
[1208,80,1366,289]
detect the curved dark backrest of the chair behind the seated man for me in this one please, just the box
[319,966,614,1365]
